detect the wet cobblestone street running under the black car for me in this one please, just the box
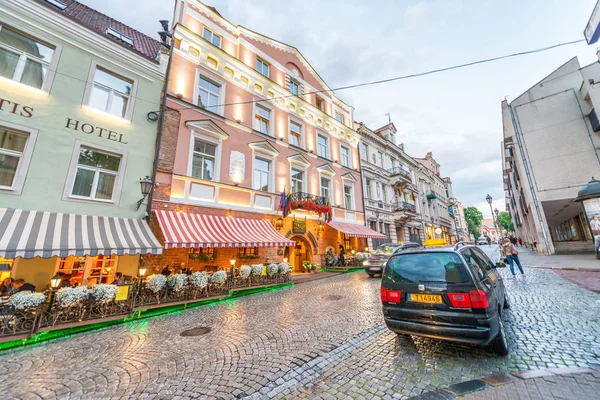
[0,262,600,400]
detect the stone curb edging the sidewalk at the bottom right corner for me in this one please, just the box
[408,367,600,400]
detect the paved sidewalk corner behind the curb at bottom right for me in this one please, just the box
[459,372,600,400]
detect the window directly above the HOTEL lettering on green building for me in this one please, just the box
[88,67,133,118]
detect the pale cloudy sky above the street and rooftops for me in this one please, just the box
[80,0,598,215]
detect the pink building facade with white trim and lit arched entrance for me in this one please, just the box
[144,0,376,270]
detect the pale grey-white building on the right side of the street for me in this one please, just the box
[502,58,600,254]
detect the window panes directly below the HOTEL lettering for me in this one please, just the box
[71,146,121,200]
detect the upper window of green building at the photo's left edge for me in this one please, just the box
[0,25,55,89]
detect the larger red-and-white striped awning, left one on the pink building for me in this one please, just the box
[155,210,296,249]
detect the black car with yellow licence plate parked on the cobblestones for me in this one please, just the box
[381,243,509,355]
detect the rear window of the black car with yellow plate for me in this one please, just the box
[383,252,470,283]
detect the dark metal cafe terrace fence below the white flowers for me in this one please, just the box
[0,271,291,342]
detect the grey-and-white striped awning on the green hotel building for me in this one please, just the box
[0,208,162,258]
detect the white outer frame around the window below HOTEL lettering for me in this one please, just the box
[63,140,128,206]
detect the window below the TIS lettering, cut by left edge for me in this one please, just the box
[0,127,29,188]
